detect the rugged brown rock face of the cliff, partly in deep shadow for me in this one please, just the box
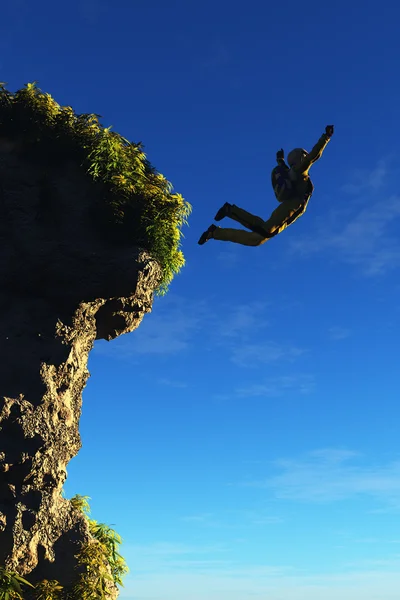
[0,139,161,596]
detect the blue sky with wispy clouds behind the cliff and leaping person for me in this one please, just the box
[0,0,400,600]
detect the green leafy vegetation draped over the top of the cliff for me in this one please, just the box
[0,83,191,294]
